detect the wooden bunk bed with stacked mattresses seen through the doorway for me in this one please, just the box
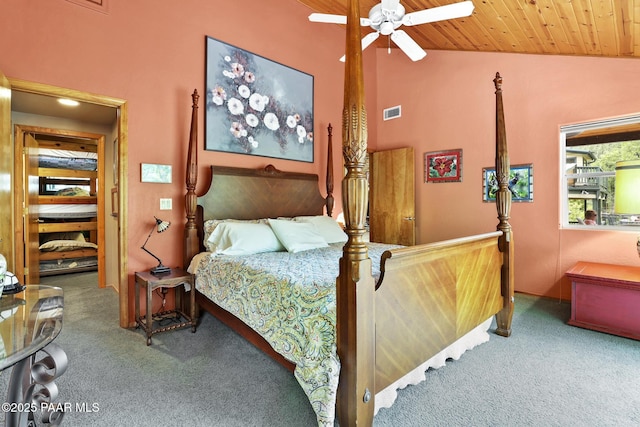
[34,146,98,276]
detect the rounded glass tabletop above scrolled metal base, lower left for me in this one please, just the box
[0,285,64,370]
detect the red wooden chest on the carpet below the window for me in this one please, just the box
[566,261,640,340]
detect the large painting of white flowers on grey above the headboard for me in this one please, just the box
[205,37,313,162]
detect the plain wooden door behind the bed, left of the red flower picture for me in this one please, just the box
[369,148,416,246]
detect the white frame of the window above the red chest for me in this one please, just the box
[560,113,640,231]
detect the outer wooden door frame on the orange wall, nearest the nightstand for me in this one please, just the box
[8,77,129,328]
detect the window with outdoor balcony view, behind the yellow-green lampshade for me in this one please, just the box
[560,115,640,229]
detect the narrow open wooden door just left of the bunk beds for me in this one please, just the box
[23,133,40,285]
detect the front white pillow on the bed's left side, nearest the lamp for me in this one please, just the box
[209,222,284,255]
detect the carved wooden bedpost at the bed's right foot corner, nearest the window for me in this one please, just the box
[493,73,514,337]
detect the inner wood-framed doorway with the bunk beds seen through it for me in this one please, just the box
[14,125,105,288]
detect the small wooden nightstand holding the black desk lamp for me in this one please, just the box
[135,268,197,345]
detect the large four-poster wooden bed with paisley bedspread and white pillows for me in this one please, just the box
[184,0,513,426]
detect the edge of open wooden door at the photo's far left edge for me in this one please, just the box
[0,71,15,272]
